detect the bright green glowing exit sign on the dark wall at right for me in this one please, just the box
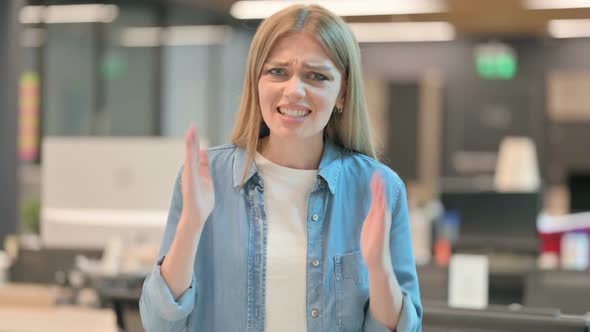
[474,43,518,80]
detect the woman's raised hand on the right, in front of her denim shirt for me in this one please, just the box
[361,172,392,272]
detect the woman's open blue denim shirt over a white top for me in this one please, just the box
[139,139,422,332]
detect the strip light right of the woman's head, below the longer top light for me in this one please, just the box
[349,22,455,43]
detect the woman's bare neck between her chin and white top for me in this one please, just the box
[258,134,324,169]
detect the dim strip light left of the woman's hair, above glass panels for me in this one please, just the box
[119,25,231,47]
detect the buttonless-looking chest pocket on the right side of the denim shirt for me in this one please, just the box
[334,251,369,332]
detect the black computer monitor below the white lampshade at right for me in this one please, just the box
[441,191,542,254]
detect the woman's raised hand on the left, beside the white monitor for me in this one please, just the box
[182,125,215,231]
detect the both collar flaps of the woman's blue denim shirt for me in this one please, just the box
[233,136,342,194]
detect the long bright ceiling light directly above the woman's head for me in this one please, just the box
[230,0,446,19]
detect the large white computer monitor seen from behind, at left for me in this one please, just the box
[41,137,184,249]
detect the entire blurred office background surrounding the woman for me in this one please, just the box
[0,0,590,331]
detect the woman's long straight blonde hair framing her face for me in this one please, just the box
[231,5,377,184]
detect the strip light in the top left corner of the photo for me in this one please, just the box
[20,4,119,24]
